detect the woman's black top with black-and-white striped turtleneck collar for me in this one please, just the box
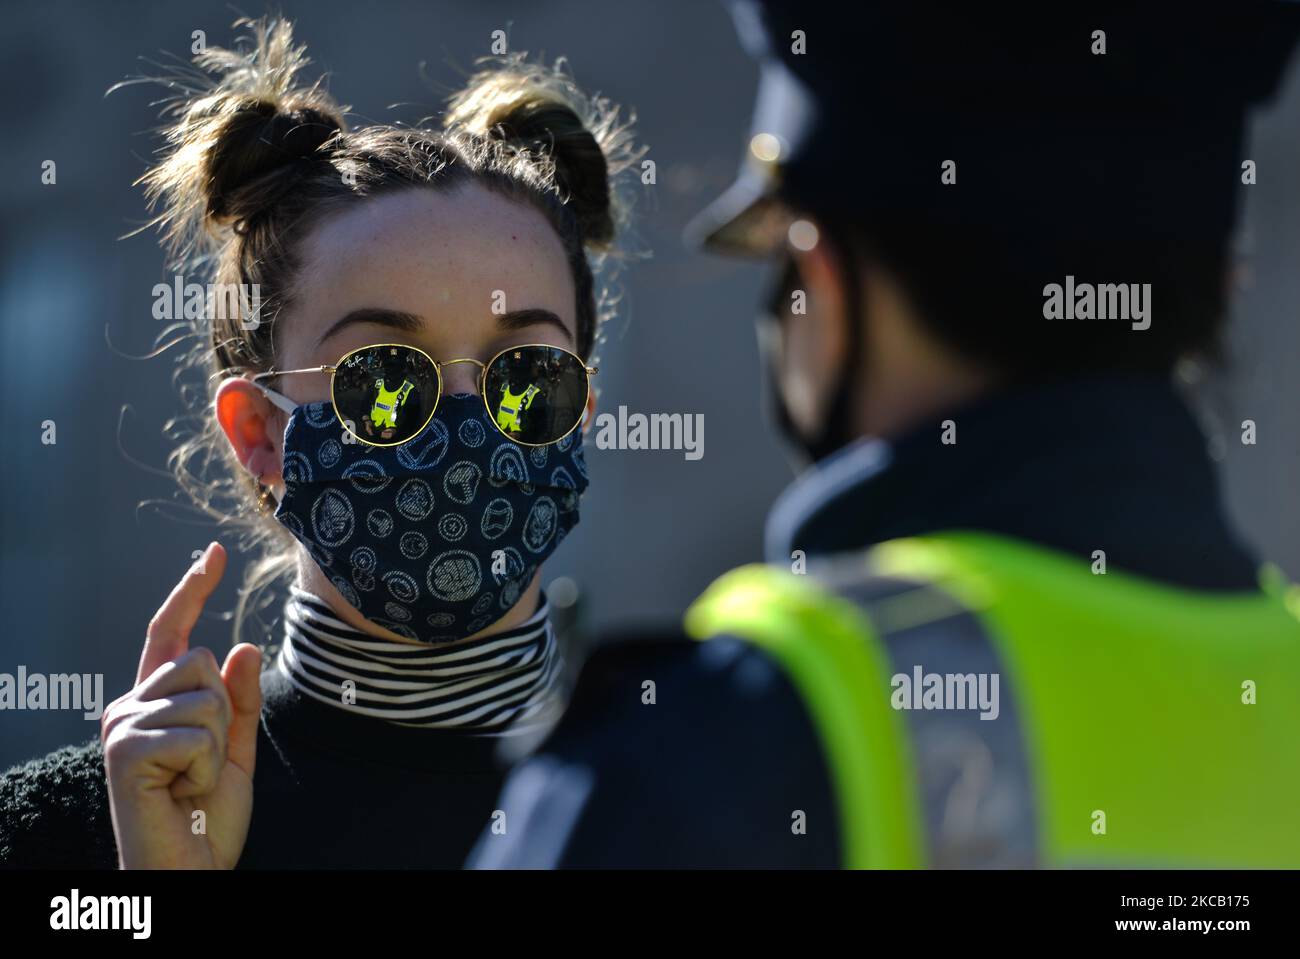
[0,590,563,869]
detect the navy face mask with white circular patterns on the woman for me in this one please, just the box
[276,394,588,643]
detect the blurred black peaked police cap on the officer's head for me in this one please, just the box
[688,0,1300,255]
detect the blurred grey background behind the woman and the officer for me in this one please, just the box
[0,0,1300,769]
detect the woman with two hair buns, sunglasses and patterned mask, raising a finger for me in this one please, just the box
[0,14,638,867]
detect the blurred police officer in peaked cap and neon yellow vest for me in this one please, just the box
[471,0,1300,868]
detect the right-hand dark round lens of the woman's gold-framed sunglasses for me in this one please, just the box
[484,346,588,446]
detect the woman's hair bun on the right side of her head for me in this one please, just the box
[446,53,641,249]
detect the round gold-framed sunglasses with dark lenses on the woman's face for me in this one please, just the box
[248,343,598,446]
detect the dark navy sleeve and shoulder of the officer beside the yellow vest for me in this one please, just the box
[468,637,840,868]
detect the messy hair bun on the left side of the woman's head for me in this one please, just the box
[133,18,346,255]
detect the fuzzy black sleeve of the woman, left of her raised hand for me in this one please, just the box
[0,741,117,869]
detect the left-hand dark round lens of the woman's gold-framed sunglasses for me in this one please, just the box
[334,346,438,446]
